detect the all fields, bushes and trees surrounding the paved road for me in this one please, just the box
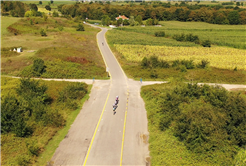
[0,0,246,166]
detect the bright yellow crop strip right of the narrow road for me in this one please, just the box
[114,44,246,70]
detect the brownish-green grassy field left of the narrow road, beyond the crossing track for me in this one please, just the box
[0,17,106,79]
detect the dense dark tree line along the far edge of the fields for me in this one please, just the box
[58,3,246,25]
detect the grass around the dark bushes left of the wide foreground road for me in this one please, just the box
[0,77,91,165]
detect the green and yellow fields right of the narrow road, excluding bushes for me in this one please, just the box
[106,21,246,84]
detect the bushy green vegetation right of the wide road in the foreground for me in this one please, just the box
[141,80,246,166]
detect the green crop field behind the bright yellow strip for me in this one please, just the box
[109,21,246,49]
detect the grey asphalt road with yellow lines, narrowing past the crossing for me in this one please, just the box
[50,29,149,166]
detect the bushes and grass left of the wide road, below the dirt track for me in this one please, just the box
[0,77,90,165]
